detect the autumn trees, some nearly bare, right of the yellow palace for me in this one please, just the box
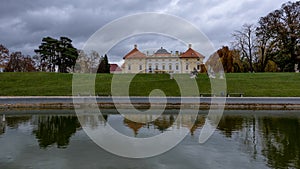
[208,1,300,72]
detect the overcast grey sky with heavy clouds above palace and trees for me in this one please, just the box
[0,0,287,62]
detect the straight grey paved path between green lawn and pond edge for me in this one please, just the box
[0,96,300,104]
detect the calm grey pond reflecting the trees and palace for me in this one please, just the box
[0,110,300,169]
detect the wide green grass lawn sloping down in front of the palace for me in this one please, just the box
[0,72,300,97]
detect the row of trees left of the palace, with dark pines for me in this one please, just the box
[0,37,110,73]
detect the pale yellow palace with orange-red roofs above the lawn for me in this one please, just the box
[122,44,204,73]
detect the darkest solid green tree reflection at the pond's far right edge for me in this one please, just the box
[259,117,300,168]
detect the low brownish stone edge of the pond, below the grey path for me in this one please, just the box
[0,96,300,111]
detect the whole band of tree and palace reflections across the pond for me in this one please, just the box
[0,113,300,169]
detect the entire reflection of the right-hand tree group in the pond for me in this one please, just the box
[218,115,300,169]
